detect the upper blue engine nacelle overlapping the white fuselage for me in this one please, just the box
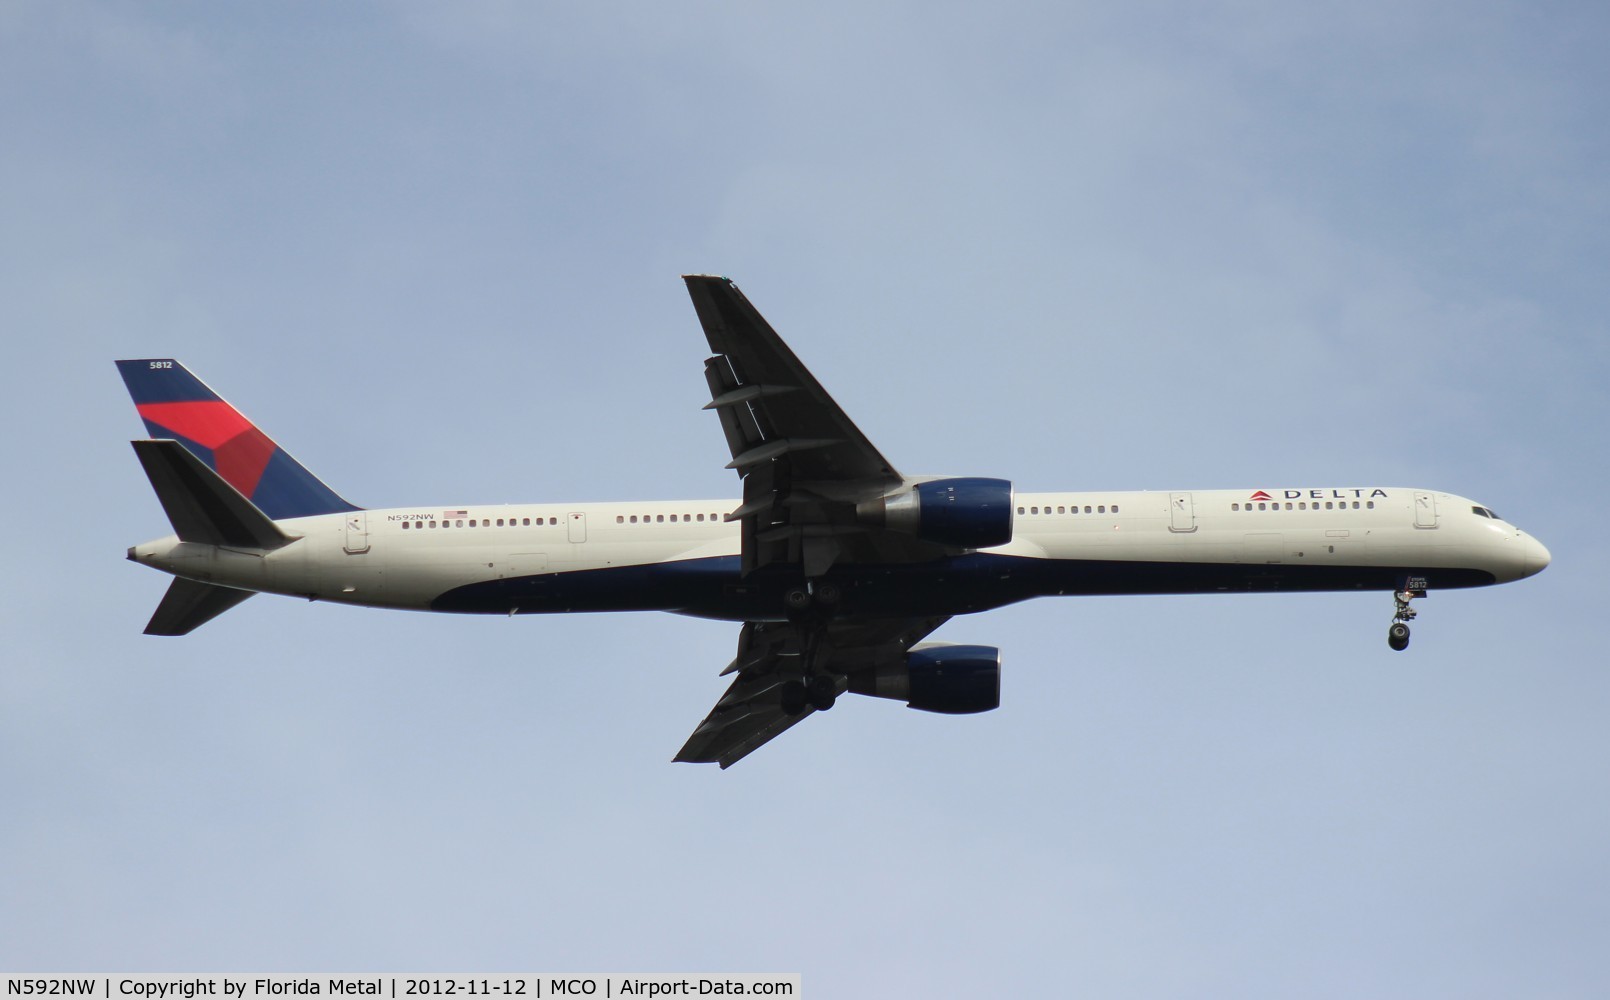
[857,478,1013,549]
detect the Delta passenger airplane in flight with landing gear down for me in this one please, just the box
[118,275,1550,768]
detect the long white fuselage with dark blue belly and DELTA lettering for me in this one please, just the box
[129,488,1549,620]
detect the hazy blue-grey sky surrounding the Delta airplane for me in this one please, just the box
[0,0,1610,998]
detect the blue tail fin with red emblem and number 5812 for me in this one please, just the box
[118,357,362,520]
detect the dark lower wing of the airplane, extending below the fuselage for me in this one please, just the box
[675,615,947,770]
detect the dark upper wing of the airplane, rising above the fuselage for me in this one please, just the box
[683,274,943,578]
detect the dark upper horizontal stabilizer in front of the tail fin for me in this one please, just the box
[130,441,291,550]
